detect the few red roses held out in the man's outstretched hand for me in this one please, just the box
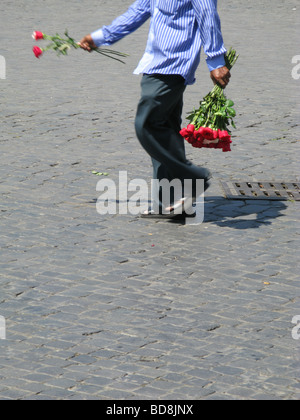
[32,30,128,64]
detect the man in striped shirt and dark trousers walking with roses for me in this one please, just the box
[80,0,230,218]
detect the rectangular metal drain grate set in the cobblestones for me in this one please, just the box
[221,181,300,201]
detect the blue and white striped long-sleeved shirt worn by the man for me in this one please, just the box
[92,0,226,84]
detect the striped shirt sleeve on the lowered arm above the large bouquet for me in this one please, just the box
[191,0,226,71]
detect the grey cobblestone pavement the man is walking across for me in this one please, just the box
[0,0,300,400]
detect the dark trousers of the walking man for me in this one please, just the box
[135,74,211,208]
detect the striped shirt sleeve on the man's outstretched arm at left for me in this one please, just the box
[91,0,151,47]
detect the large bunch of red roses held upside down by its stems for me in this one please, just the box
[180,48,238,152]
